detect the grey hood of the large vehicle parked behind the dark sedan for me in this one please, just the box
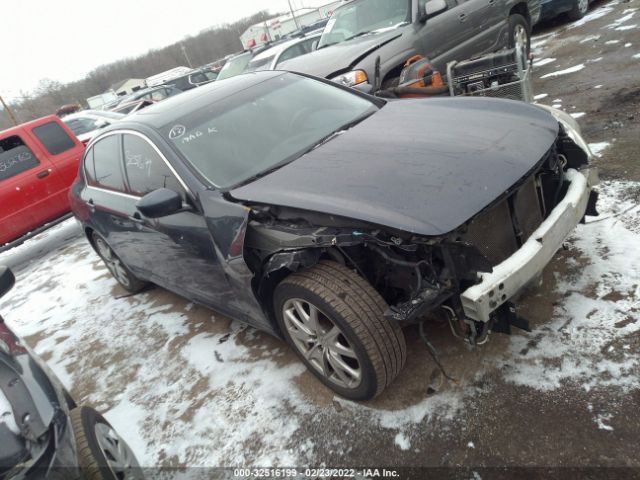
[278,26,407,78]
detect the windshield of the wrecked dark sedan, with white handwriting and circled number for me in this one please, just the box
[161,74,378,189]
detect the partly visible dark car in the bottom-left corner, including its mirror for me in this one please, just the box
[0,266,142,480]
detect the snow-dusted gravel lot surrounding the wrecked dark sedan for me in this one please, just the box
[0,0,640,472]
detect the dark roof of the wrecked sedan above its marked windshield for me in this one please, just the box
[113,70,294,132]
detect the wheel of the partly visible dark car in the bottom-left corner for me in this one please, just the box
[70,407,143,480]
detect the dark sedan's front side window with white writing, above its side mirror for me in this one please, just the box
[123,134,184,196]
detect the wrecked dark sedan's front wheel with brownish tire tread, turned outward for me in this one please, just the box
[274,261,407,400]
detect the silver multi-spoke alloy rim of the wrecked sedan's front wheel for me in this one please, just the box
[282,298,362,389]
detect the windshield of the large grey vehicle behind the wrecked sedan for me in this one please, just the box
[318,0,411,48]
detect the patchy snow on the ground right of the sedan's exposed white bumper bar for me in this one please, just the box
[505,182,640,391]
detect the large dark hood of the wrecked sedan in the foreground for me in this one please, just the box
[229,98,559,236]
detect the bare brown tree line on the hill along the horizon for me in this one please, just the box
[0,11,271,130]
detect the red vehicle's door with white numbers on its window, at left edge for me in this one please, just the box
[0,131,62,244]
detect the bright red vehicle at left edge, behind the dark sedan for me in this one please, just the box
[0,115,84,246]
